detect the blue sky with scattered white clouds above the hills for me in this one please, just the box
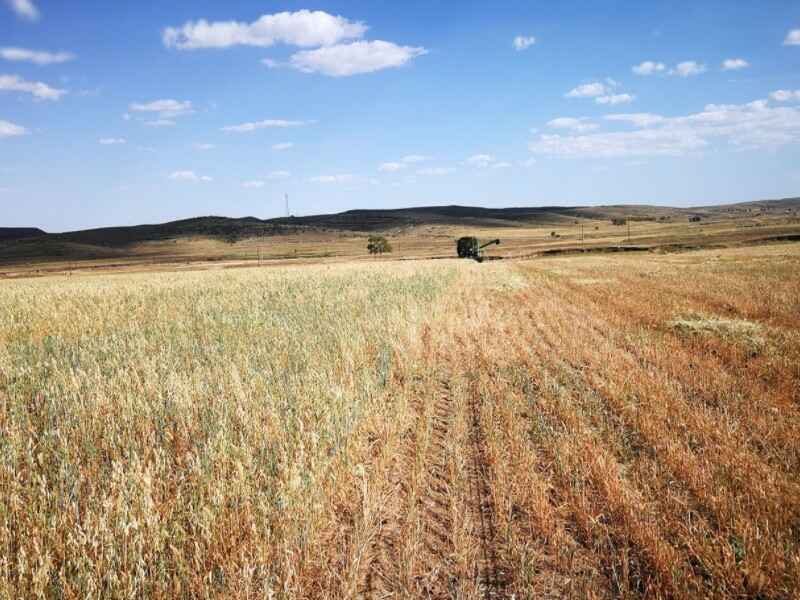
[0,0,800,231]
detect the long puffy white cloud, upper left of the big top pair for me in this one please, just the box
[162,10,367,50]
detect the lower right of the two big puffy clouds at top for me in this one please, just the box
[289,40,428,77]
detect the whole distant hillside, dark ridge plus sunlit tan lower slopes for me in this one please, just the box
[0,198,800,265]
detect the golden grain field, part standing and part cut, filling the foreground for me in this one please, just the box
[0,244,800,599]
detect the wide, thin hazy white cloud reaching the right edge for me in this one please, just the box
[530,100,800,158]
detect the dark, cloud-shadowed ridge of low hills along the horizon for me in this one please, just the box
[0,198,800,263]
